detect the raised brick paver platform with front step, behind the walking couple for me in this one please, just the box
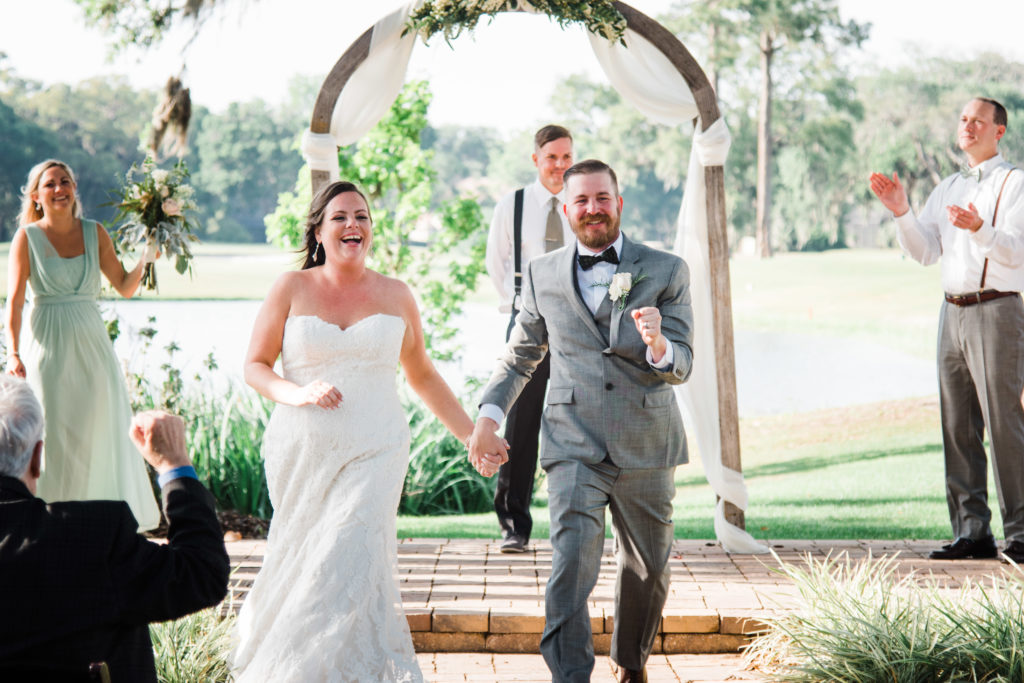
[227,539,1001,654]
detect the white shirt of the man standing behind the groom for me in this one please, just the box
[484,179,575,313]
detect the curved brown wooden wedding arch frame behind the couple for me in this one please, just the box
[309,1,744,528]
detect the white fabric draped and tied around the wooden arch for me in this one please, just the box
[302,0,768,553]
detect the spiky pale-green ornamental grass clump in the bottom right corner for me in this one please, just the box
[745,553,1024,683]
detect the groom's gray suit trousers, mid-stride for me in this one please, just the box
[541,458,676,683]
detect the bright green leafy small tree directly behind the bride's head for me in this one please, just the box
[266,81,485,360]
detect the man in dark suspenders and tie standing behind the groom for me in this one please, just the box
[486,125,575,553]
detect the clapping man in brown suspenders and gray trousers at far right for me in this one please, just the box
[870,97,1024,563]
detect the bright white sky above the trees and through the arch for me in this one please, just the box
[0,0,1024,131]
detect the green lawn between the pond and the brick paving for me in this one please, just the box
[398,398,978,540]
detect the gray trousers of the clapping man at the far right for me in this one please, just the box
[938,297,1024,542]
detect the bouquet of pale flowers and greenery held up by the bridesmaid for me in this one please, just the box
[114,157,199,290]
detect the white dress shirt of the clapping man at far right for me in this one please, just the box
[896,155,1024,294]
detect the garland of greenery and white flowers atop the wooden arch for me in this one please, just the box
[406,0,626,42]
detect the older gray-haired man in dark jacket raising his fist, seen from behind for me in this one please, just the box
[0,376,228,681]
